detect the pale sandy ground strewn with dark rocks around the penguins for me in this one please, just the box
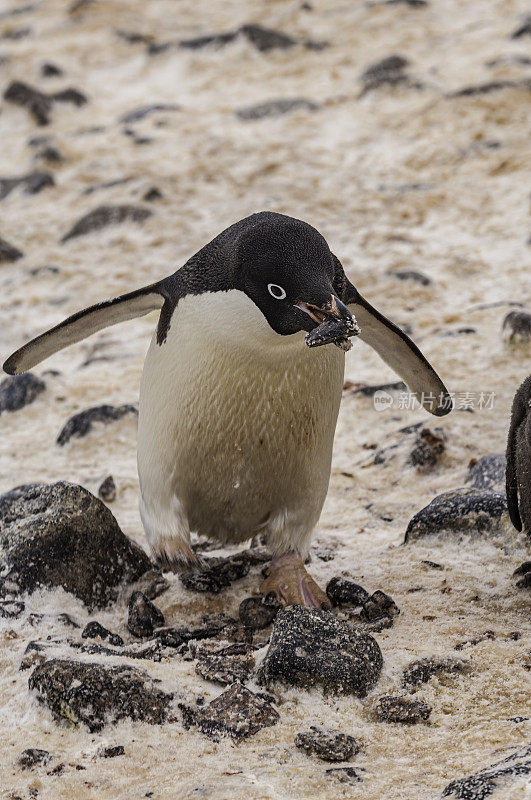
[0,0,531,800]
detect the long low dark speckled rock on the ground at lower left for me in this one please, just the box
[28,659,172,732]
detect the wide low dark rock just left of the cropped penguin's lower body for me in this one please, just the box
[404,489,507,542]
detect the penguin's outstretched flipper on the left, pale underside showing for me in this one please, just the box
[4,283,165,375]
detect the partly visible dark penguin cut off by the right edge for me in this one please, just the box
[505,375,531,587]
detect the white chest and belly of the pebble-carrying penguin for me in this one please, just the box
[138,290,344,540]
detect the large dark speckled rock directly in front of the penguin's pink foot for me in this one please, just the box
[258,605,383,697]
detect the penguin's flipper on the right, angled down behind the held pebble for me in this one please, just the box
[343,284,453,417]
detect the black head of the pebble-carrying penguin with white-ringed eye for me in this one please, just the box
[236,212,355,344]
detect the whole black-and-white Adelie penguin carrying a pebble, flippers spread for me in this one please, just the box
[4,212,452,607]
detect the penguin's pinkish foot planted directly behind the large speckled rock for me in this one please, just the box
[260,550,330,609]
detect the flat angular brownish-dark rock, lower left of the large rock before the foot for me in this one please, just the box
[194,683,280,739]
